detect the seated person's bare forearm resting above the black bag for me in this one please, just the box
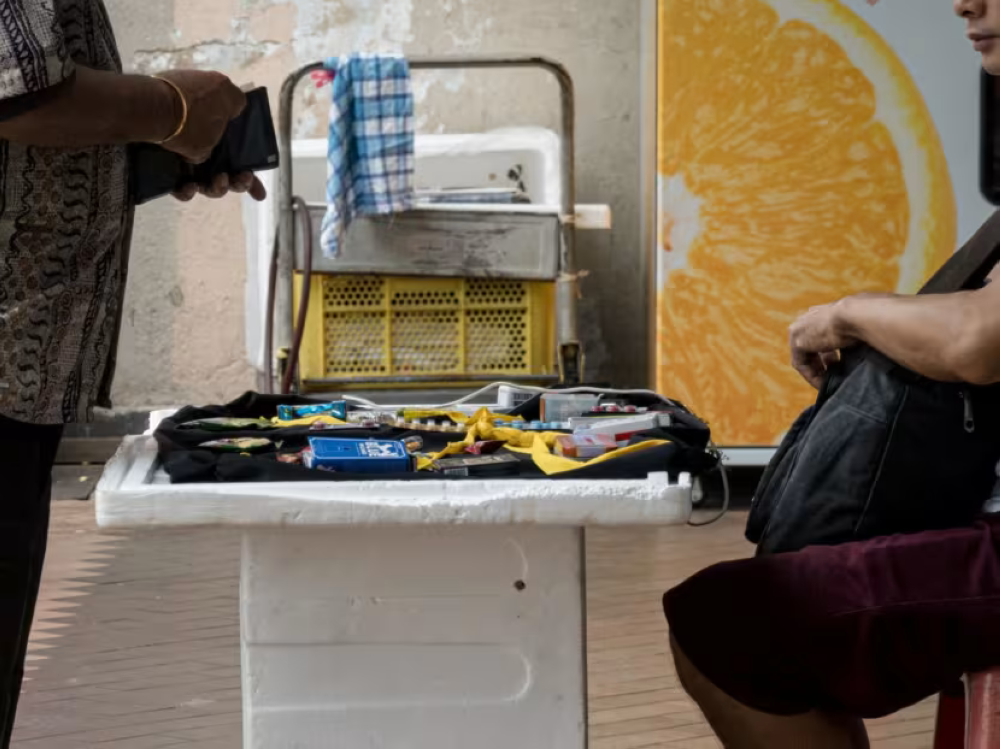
[838,291,1000,384]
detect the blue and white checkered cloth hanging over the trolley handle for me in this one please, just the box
[321,55,414,258]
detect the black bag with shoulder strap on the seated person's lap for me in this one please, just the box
[746,212,1000,554]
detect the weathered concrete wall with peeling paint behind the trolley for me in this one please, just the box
[106,0,648,407]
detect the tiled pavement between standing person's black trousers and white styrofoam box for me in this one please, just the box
[14,502,242,749]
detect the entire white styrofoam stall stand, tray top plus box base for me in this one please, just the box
[95,420,691,749]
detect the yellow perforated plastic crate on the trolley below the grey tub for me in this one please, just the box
[295,274,556,387]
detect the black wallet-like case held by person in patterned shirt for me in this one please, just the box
[129,87,278,205]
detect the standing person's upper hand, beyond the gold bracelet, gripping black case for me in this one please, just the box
[160,70,247,164]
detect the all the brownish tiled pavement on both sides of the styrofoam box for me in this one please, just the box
[14,496,934,749]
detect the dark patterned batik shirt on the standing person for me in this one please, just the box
[0,0,132,424]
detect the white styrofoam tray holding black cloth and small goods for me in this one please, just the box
[94,436,691,527]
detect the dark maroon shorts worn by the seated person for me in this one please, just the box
[664,518,1000,718]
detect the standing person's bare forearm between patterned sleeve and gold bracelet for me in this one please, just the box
[0,67,181,148]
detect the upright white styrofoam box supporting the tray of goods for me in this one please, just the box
[241,526,585,749]
